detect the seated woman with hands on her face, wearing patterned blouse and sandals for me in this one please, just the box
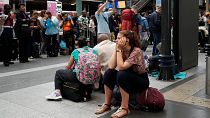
[95,31,149,118]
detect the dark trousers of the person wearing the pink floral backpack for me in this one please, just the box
[54,69,92,94]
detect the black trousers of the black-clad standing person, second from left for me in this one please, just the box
[17,27,32,62]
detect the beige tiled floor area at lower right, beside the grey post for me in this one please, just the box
[164,74,210,108]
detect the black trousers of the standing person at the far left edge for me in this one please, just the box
[0,28,13,62]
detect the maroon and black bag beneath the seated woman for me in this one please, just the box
[111,86,165,112]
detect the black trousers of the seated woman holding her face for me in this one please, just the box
[103,69,149,94]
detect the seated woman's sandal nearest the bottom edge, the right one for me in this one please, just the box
[111,107,130,118]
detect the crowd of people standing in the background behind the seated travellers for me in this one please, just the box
[0,2,160,66]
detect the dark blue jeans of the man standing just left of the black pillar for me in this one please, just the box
[152,32,161,55]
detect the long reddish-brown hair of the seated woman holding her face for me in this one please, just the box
[119,30,141,48]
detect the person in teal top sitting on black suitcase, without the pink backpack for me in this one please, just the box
[46,37,97,100]
